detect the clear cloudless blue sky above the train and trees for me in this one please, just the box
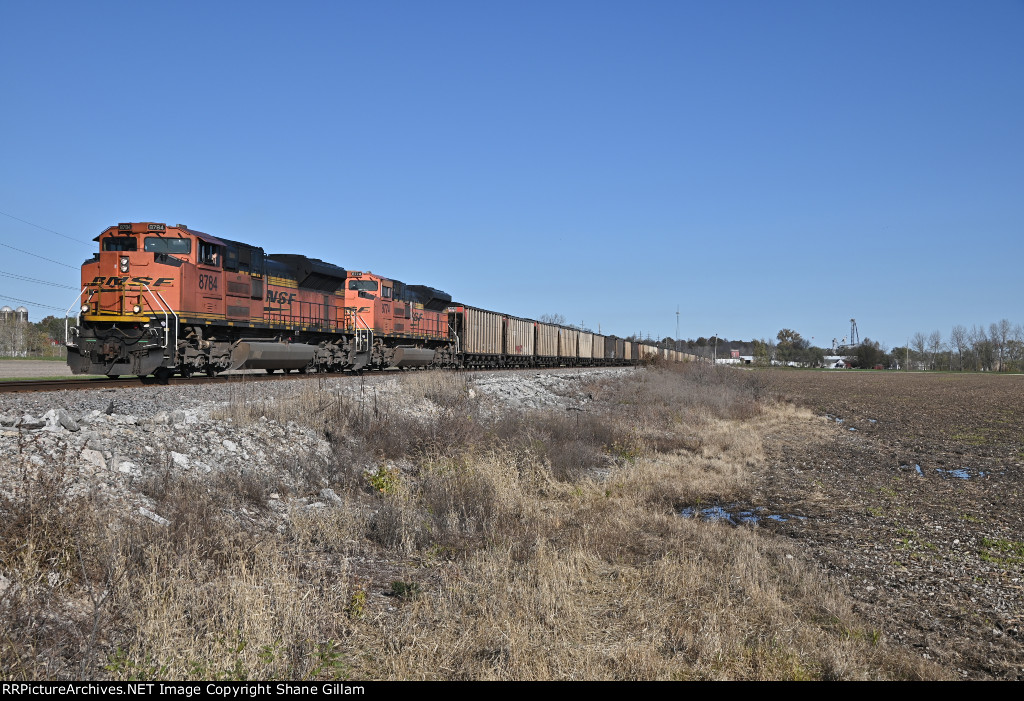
[0,0,1024,347]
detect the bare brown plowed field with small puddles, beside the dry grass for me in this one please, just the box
[750,370,1024,680]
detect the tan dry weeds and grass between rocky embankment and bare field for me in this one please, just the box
[0,364,940,680]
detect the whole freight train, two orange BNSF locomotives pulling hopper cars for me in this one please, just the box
[67,222,688,377]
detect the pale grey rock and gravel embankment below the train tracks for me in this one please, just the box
[0,368,633,522]
